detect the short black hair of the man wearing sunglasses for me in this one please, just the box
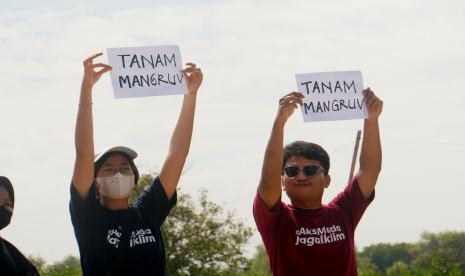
[283,141,329,174]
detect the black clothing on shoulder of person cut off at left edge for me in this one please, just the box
[0,238,39,276]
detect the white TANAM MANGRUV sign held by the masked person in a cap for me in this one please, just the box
[107,46,187,98]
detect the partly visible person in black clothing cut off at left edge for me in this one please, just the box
[0,176,39,276]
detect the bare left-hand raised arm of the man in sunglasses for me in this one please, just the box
[258,92,304,210]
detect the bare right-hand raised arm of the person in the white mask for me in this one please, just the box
[160,63,203,199]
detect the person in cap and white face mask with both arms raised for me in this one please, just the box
[70,53,203,275]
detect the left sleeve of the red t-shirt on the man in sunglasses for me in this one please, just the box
[253,191,283,244]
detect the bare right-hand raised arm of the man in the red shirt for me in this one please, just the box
[358,88,383,198]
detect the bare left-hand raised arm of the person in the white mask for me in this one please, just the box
[73,53,111,198]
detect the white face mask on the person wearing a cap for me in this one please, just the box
[96,172,134,199]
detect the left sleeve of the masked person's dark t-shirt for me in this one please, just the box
[69,184,100,244]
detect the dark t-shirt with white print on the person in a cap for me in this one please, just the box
[70,177,176,275]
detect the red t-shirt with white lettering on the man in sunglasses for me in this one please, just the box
[253,177,375,276]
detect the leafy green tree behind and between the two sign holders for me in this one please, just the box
[132,175,252,275]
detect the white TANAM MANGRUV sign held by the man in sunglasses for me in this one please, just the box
[295,71,368,122]
